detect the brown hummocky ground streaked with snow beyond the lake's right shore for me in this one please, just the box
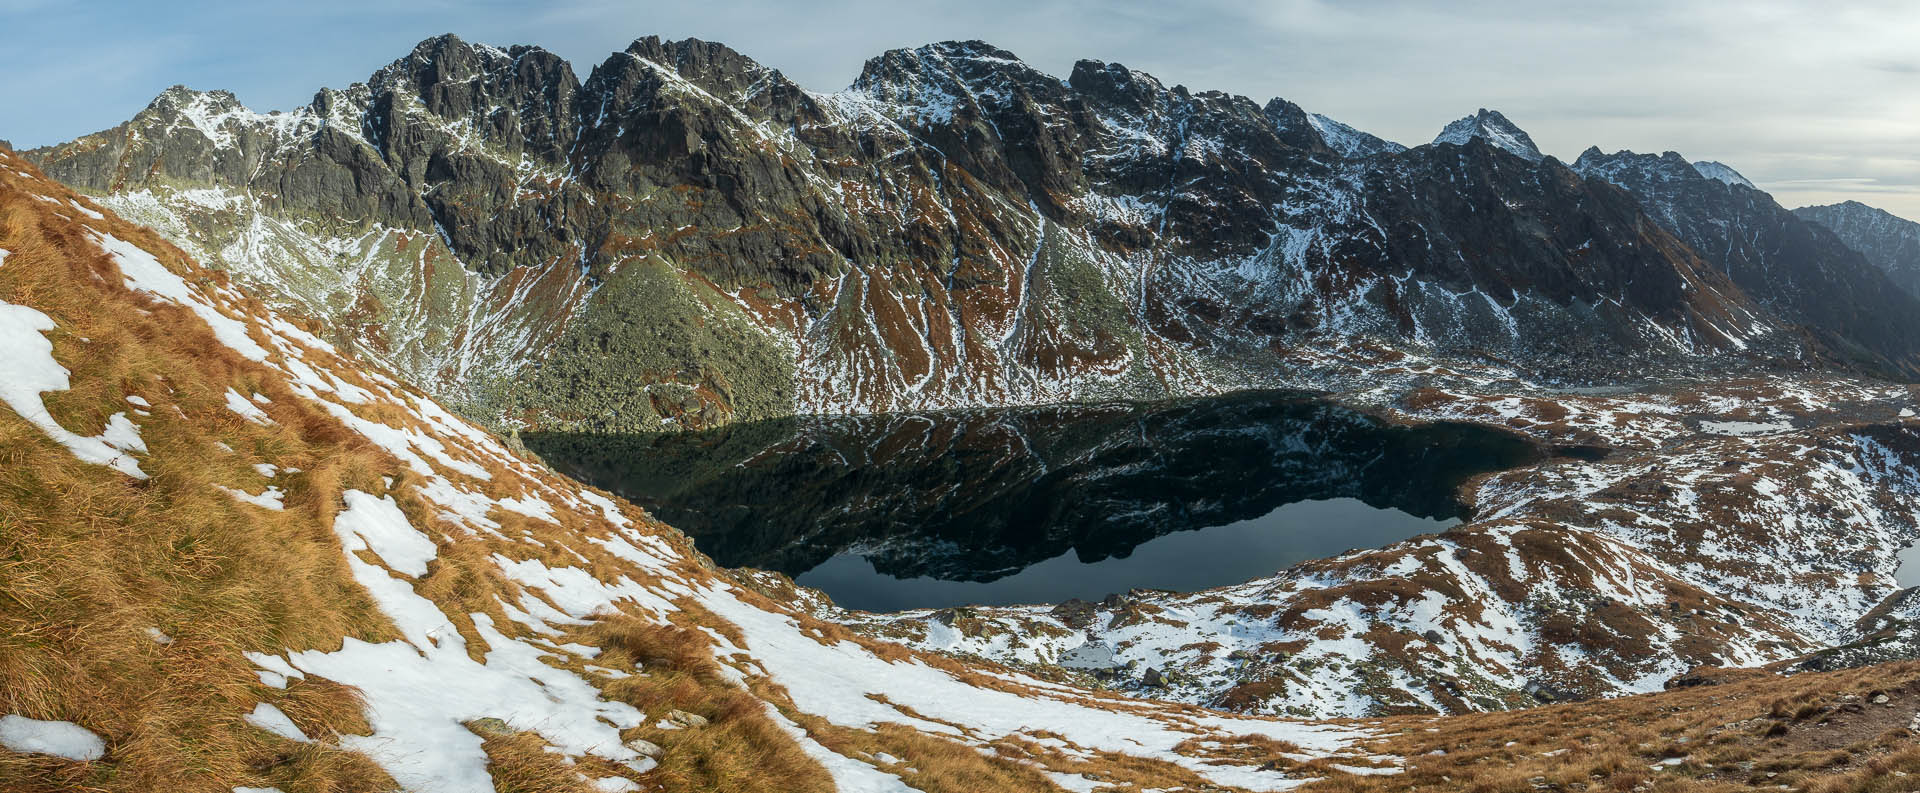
[839,380,1920,716]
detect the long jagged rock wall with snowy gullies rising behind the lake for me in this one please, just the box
[31,36,1893,430]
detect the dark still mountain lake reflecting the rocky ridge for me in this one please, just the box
[524,392,1542,611]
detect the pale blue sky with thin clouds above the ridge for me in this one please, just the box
[11,0,1920,219]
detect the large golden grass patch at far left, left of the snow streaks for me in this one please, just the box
[0,162,405,793]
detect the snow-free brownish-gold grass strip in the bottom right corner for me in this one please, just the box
[1302,662,1920,793]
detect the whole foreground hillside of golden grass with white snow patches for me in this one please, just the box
[0,150,1920,793]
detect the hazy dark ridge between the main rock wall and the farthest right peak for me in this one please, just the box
[1574,148,1920,374]
